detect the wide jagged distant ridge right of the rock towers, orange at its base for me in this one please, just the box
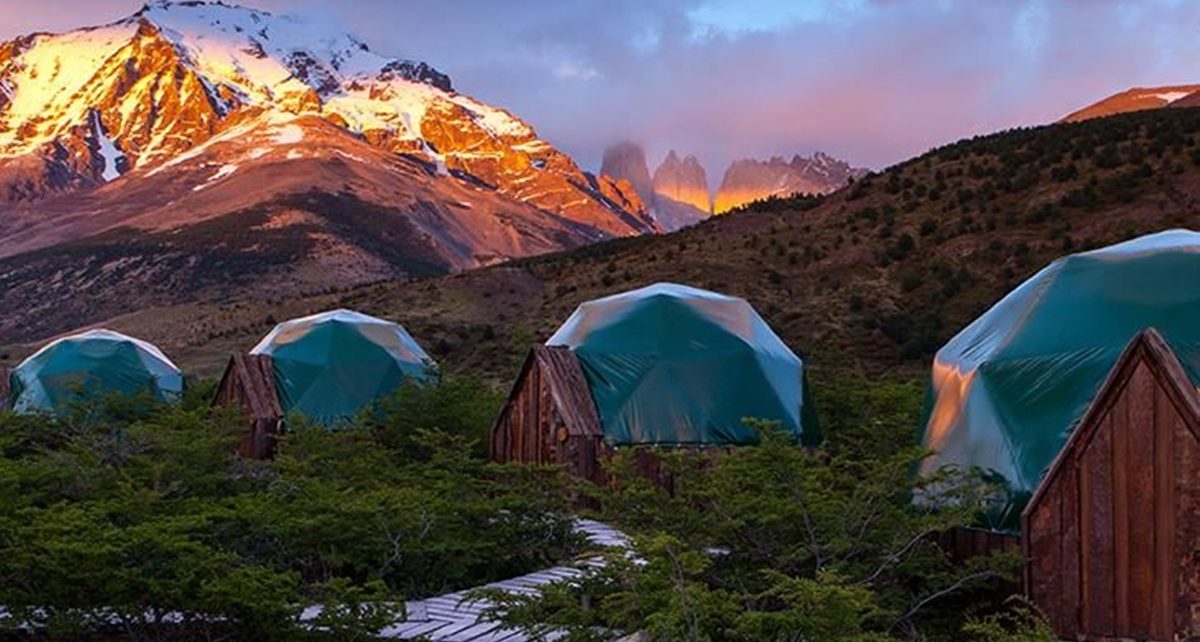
[713,151,866,214]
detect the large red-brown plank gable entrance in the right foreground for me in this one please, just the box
[1021,330,1200,641]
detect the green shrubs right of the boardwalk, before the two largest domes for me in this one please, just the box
[487,379,1051,642]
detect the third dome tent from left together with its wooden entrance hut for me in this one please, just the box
[491,283,820,479]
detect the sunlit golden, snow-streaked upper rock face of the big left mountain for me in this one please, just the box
[0,1,660,236]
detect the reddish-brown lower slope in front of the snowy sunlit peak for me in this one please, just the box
[0,116,624,336]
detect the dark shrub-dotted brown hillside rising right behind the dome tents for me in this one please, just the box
[11,109,1200,382]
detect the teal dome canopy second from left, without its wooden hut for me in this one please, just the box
[251,310,437,426]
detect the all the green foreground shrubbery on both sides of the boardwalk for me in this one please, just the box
[0,369,1044,642]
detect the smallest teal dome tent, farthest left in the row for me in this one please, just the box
[10,330,184,413]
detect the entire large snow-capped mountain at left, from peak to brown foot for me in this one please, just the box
[0,1,661,338]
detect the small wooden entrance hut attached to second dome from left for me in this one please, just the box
[212,354,283,460]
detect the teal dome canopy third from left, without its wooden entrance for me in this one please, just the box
[547,283,817,445]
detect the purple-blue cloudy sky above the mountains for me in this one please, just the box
[0,0,1200,176]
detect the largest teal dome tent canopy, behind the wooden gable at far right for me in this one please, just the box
[923,230,1200,526]
